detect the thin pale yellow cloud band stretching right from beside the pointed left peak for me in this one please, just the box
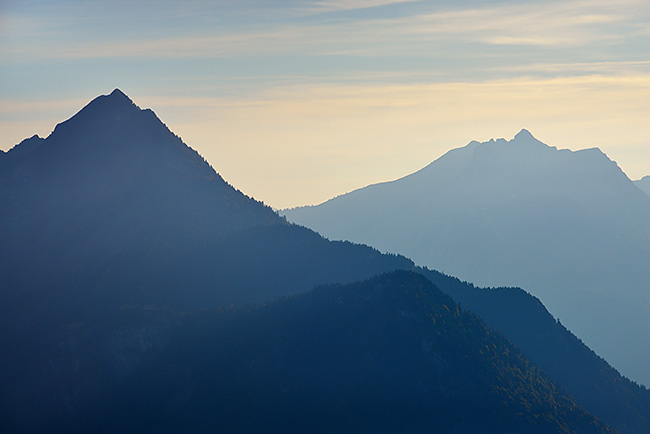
[133,74,650,117]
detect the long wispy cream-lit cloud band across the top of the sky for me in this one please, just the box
[2,0,650,59]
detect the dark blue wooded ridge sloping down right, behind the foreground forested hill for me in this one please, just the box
[415,267,650,434]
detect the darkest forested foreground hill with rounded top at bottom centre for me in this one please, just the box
[1,271,615,434]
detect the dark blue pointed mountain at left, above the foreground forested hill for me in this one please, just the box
[0,90,412,316]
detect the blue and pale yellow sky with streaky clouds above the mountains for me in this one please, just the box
[0,0,650,208]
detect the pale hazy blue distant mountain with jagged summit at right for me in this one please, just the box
[284,130,650,384]
